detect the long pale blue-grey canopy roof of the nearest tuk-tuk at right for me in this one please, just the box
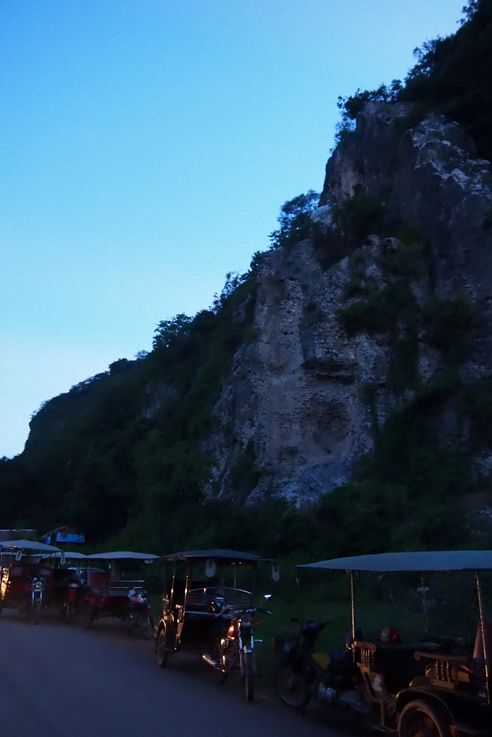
[298,550,492,573]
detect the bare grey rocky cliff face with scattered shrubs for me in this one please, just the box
[207,103,492,504]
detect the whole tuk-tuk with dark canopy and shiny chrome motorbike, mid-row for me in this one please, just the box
[155,549,274,701]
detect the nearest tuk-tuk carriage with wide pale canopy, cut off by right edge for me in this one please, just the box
[292,550,492,737]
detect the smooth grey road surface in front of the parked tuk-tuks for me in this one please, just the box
[0,610,356,737]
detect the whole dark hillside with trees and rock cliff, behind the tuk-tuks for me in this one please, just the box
[0,2,492,554]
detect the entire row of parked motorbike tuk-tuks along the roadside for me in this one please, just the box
[0,541,492,737]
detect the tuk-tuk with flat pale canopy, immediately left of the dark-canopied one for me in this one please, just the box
[79,550,159,639]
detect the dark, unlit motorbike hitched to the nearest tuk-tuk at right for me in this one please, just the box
[273,618,368,713]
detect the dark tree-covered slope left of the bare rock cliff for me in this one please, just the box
[0,266,255,550]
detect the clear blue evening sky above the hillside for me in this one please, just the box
[0,0,464,457]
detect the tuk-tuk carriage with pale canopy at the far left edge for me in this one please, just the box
[0,540,60,624]
